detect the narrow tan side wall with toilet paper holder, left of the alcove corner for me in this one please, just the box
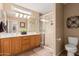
[56,3,64,55]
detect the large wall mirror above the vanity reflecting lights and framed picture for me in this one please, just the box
[0,4,39,33]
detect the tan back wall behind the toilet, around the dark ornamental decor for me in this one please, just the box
[64,3,79,48]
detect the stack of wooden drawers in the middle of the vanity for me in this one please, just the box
[21,36,30,51]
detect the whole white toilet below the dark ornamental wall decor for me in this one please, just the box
[65,37,78,56]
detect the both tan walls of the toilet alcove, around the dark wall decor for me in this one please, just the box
[56,3,79,55]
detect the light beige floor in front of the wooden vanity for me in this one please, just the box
[18,47,53,56]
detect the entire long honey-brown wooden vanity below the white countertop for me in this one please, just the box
[0,34,41,56]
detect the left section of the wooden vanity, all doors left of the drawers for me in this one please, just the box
[1,37,21,55]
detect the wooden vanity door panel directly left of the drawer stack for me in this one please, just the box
[11,37,21,55]
